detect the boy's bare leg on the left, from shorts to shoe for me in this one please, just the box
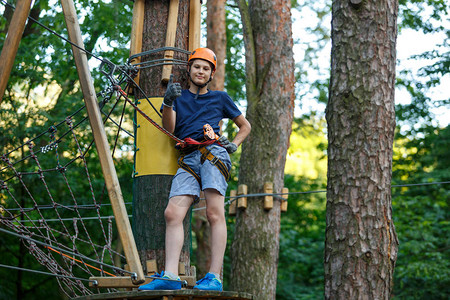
[164,195,194,275]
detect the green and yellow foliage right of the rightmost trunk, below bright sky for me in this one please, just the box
[392,126,450,299]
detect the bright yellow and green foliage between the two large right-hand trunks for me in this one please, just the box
[277,113,326,299]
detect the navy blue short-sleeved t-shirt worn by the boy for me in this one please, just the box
[173,90,242,141]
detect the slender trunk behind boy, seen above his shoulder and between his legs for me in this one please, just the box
[192,0,227,278]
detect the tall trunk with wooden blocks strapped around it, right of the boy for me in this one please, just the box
[230,0,295,299]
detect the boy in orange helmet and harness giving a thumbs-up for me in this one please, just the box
[139,48,251,291]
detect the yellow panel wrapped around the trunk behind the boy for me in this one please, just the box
[136,98,178,176]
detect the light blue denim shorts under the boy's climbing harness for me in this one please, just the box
[169,144,231,198]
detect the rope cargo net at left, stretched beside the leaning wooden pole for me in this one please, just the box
[0,83,134,297]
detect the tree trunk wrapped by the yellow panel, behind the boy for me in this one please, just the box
[133,0,191,275]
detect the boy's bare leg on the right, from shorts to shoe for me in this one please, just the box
[204,189,227,274]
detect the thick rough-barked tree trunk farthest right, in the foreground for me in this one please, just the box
[325,0,398,299]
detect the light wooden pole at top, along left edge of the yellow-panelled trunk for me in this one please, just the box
[128,0,145,93]
